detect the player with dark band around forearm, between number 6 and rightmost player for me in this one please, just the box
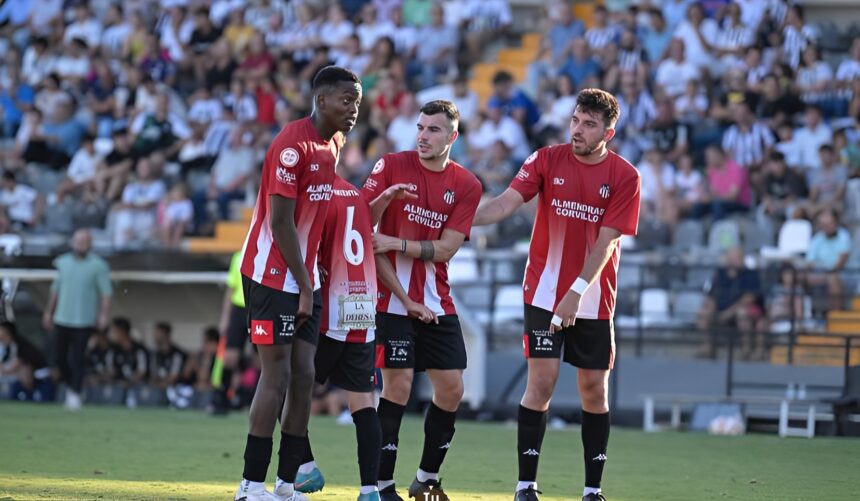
[362,101,481,501]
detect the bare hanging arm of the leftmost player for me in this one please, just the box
[269,195,314,322]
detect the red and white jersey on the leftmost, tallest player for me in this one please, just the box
[242,117,343,293]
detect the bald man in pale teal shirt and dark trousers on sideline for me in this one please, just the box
[42,230,113,410]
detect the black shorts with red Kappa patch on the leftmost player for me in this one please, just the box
[242,276,322,346]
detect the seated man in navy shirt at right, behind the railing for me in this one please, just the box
[697,247,766,360]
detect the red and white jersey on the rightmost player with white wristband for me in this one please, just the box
[510,143,641,320]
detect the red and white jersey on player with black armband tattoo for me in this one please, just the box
[362,151,481,315]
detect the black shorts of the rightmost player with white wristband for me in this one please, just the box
[523,304,615,370]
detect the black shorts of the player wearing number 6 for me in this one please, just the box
[314,336,376,393]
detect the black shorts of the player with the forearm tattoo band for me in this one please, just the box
[376,313,466,371]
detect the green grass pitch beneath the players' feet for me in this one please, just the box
[0,403,860,501]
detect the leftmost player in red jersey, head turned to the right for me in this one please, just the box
[235,66,362,501]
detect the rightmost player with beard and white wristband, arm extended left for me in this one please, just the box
[474,89,641,501]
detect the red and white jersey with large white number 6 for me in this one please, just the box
[320,177,376,343]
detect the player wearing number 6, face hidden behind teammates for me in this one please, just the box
[295,177,418,501]
